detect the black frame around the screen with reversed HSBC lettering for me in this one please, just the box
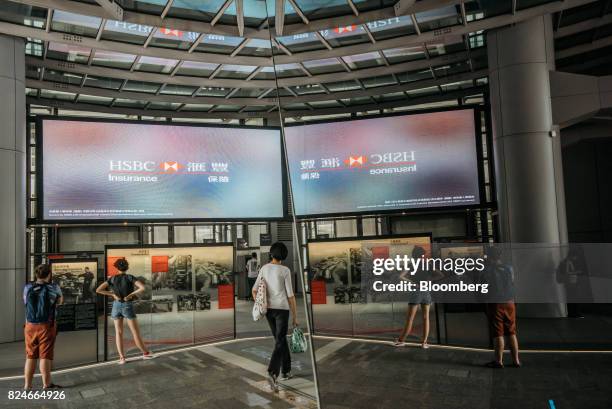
[282,104,497,221]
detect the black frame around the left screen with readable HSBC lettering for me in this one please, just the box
[32,115,290,224]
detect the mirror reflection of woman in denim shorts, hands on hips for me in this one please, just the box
[394,246,432,349]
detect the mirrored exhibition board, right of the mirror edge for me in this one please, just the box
[308,233,435,339]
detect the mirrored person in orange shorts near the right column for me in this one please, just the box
[483,247,521,368]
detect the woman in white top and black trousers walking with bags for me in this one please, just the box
[252,242,298,392]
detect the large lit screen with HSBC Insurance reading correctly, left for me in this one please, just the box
[42,119,284,220]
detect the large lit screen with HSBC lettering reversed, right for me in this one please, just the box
[285,109,480,216]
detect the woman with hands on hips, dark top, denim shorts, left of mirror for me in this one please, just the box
[96,258,153,365]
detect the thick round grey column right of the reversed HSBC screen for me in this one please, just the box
[487,15,567,317]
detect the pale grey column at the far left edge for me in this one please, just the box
[0,35,26,342]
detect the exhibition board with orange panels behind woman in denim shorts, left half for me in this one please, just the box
[105,243,235,357]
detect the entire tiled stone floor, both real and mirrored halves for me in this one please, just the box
[0,337,612,409]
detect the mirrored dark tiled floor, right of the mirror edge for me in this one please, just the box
[315,339,612,409]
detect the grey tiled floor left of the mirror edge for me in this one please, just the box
[0,340,316,409]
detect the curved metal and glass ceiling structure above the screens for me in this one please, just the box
[0,0,612,121]
